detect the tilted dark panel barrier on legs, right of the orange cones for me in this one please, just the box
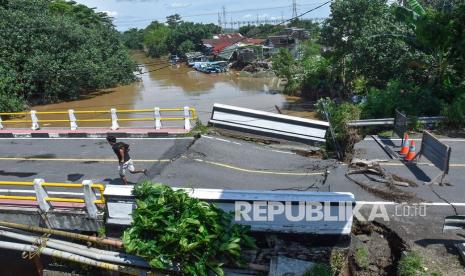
[412,131,452,184]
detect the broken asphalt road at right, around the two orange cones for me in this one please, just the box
[332,138,465,276]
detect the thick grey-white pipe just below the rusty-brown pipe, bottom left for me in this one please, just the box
[0,230,150,268]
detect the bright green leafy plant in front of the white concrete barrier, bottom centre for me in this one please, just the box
[123,182,255,275]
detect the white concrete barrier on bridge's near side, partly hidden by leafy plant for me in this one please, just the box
[104,185,355,236]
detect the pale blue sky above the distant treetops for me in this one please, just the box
[75,0,329,31]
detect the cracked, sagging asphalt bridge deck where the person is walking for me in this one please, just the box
[0,136,335,191]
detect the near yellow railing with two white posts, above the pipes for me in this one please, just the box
[0,179,105,218]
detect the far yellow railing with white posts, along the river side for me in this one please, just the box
[0,106,197,130]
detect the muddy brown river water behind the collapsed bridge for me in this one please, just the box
[21,52,313,127]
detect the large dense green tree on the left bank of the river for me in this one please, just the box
[0,0,137,111]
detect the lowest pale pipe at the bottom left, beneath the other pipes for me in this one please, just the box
[0,241,150,275]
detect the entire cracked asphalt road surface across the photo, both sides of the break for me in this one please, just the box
[0,136,465,275]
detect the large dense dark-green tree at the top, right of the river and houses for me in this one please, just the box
[321,0,425,95]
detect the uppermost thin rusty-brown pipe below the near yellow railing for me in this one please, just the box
[0,220,123,248]
